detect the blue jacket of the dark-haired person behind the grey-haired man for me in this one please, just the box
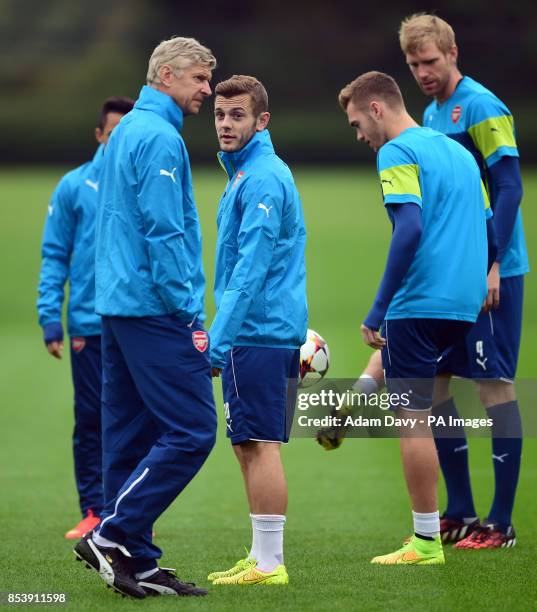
[37,146,103,336]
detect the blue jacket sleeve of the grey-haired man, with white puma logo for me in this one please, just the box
[136,134,197,318]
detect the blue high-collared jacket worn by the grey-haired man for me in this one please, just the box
[95,86,205,321]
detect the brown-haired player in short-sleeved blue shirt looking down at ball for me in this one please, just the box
[339,72,490,565]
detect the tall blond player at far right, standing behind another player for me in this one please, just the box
[399,14,529,549]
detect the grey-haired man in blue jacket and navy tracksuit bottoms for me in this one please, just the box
[75,37,216,599]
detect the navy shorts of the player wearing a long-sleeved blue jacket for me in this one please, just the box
[222,346,300,444]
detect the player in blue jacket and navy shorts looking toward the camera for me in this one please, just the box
[208,76,307,585]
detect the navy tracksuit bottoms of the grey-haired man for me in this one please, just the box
[99,315,216,572]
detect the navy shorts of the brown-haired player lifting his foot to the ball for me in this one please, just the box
[382,319,473,410]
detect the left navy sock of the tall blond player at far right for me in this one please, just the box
[432,398,476,521]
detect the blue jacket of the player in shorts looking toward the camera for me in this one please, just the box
[209,130,308,368]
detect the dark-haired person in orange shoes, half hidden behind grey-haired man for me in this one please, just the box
[37,97,134,539]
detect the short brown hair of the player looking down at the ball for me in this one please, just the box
[338,70,404,111]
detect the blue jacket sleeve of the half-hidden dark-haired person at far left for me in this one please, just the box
[37,177,76,327]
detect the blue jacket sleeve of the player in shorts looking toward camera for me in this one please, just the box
[209,177,285,368]
